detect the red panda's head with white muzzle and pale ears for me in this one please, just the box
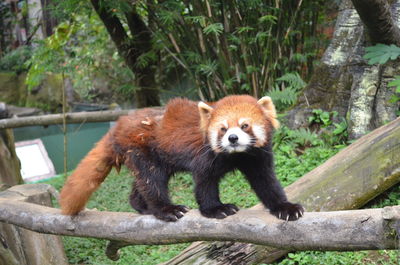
[199,95,279,153]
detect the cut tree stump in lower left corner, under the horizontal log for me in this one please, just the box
[0,184,68,265]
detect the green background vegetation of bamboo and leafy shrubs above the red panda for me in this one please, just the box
[0,0,336,103]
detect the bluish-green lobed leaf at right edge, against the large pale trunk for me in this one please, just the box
[363,44,400,65]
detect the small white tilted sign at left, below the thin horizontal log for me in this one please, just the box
[15,139,56,182]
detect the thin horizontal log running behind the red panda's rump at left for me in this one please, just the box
[0,110,132,129]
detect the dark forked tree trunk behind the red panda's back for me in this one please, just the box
[91,0,160,108]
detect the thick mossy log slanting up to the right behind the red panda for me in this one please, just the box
[165,118,400,265]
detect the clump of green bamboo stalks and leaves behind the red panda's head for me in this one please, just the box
[137,0,325,99]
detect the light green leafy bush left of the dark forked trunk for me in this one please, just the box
[26,14,138,100]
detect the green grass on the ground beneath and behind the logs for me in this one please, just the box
[47,144,400,265]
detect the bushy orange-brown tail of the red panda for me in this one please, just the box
[60,133,116,215]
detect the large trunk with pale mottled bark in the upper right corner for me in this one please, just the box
[287,0,400,139]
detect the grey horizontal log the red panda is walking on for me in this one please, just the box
[0,184,400,256]
